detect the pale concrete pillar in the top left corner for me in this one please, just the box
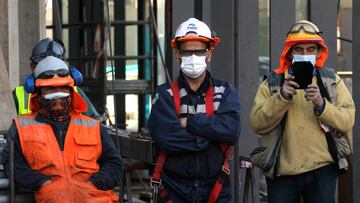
[0,0,45,89]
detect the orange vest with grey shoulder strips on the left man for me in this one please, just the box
[15,112,118,203]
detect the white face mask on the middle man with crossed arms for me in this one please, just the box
[181,54,206,79]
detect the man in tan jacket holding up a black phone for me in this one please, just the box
[250,21,355,203]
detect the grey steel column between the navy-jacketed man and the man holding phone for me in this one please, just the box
[234,0,259,202]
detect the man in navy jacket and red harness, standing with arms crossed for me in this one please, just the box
[148,18,240,203]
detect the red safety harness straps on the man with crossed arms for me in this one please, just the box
[150,81,233,203]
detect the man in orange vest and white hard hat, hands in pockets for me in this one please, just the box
[8,56,122,203]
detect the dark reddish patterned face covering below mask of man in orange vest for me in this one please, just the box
[39,96,71,121]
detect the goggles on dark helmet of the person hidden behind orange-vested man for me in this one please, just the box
[30,41,65,64]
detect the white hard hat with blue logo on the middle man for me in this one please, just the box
[171,18,220,49]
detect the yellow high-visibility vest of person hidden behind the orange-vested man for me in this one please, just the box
[15,86,78,116]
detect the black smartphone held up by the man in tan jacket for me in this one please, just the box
[292,61,314,89]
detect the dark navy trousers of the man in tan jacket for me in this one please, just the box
[266,164,338,203]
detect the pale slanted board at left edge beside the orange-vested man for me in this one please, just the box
[0,47,16,131]
